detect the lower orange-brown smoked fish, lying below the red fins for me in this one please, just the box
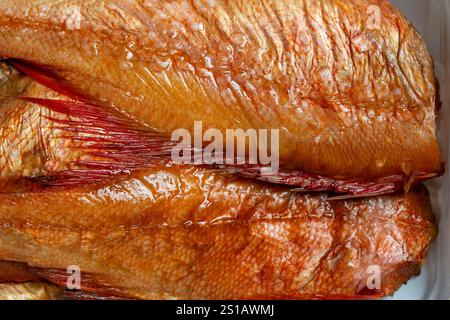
[0,168,436,299]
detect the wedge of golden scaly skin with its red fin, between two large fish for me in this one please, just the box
[0,62,174,193]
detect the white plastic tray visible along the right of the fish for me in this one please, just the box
[389,0,450,300]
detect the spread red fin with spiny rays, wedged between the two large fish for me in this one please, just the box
[22,97,174,187]
